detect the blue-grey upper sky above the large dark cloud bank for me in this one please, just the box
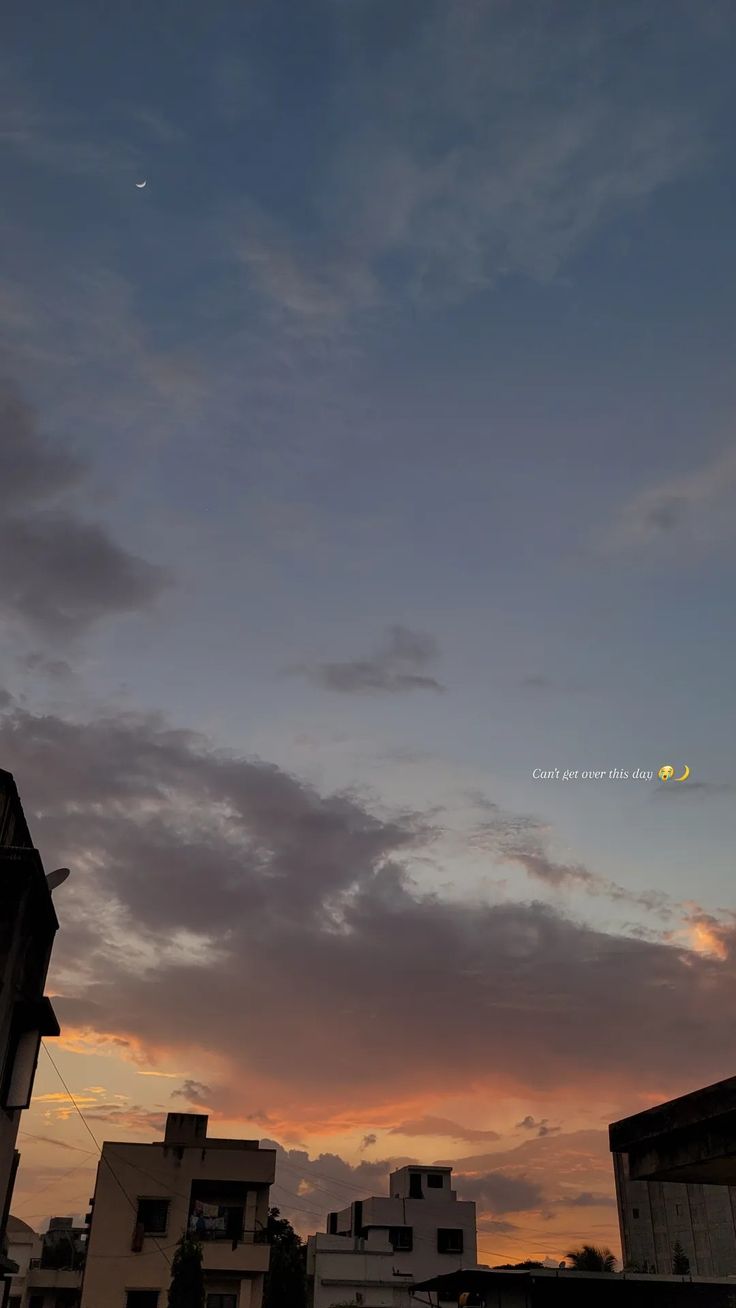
[0,0,736,1260]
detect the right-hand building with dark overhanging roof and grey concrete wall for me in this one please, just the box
[609,1078,736,1277]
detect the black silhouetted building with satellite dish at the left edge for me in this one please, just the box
[0,770,64,1308]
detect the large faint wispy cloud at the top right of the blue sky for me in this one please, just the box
[237,0,705,322]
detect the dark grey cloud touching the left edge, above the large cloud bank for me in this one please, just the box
[0,385,169,640]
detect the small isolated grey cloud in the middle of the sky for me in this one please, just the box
[289,625,444,695]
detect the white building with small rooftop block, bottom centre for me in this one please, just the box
[307,1167,476,1308]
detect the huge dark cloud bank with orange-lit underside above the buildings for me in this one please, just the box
[0,710,736,1119]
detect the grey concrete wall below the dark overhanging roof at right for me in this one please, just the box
[613,1154,736,1277]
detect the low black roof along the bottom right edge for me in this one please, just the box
[412,1267,736,1308]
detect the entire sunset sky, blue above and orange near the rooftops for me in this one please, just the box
[0,0,736,1262]
